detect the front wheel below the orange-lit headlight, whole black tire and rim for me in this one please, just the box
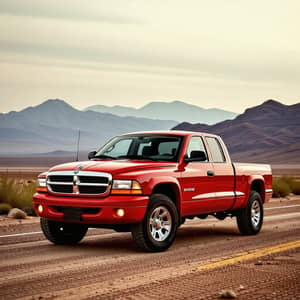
[131,194,179,252]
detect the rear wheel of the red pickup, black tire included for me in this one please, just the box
[236,191,264,235]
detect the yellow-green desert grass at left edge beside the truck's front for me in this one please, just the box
[0,176,36,215]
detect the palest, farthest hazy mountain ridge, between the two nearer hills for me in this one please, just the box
[85,101,237,124]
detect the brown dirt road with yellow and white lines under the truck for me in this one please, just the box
[0,197,300,299]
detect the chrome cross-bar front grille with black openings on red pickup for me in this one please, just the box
[47,170,112,196]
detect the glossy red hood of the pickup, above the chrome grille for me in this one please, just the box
[49,160,176,175]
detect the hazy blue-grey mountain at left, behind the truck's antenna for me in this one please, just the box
[0,99,177,153]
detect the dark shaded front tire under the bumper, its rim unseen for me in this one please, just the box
[40,218,88,245]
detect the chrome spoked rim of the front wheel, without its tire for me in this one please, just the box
[149,206,172,242]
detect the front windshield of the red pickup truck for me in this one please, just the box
[95,135,182,161]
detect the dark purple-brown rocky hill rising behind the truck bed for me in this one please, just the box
[173,100,300,164]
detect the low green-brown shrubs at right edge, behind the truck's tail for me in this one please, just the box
[273,176,300,198]
